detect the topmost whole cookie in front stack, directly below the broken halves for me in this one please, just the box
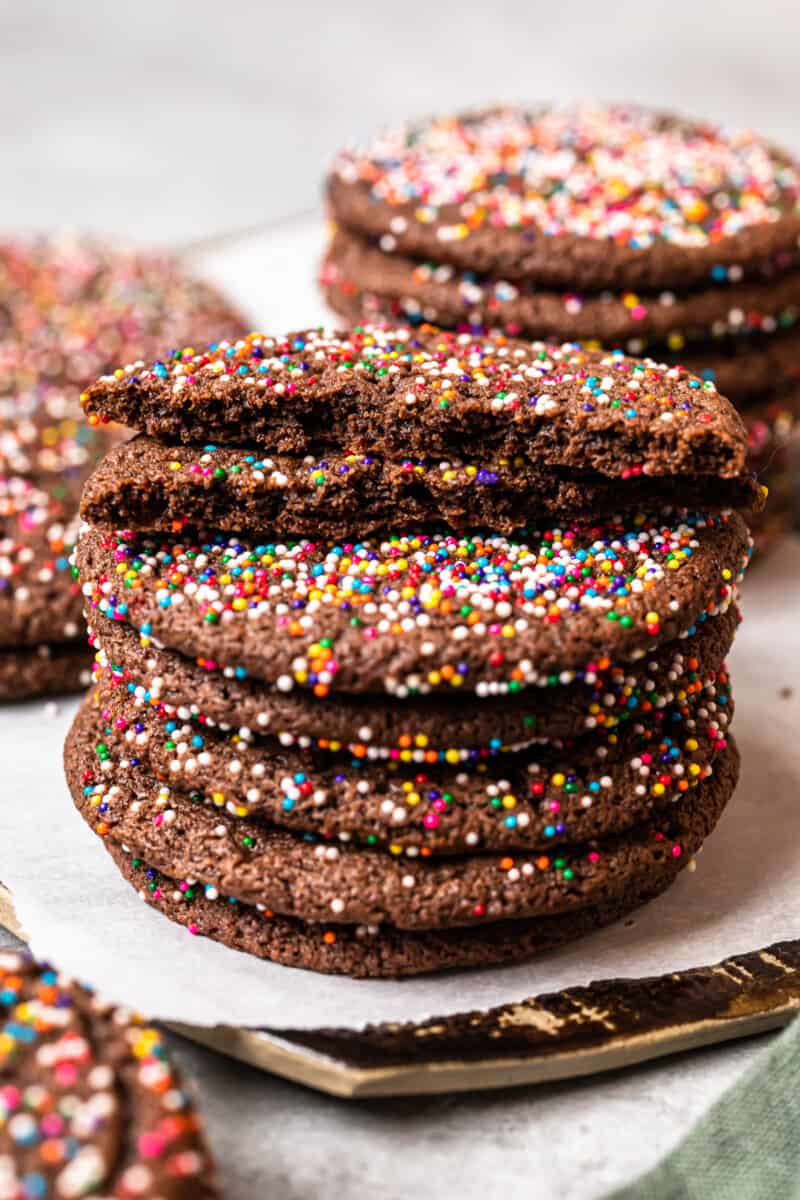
[74,514,748,697]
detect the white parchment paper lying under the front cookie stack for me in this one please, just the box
[0,224,800,1028]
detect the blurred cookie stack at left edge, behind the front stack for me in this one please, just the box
[0,238,243,701]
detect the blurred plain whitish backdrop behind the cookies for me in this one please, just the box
[0,0,800,241]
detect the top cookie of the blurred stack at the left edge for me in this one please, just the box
[0,238,242,499]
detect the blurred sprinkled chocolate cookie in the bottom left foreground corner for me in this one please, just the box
[0,950,218,1200]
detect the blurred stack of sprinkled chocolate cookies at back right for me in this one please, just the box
[321,106,800,547]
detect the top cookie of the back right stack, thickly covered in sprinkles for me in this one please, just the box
[327,104,800,292]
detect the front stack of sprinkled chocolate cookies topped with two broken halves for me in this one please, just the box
[65,326,760,977]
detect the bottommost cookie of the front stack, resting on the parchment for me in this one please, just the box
[106,841,681,979]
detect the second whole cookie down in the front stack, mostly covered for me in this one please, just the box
[91,605,739,764]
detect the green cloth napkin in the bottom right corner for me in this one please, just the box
[606,1018,800,1200]
